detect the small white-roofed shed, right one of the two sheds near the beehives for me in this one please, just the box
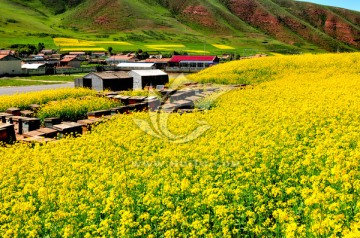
[129,69,169,90]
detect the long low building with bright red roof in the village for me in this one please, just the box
[166,55,220,72]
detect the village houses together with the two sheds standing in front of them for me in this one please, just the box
[0,49,262,91]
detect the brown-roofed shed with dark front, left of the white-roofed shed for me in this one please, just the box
[75,71,133,91]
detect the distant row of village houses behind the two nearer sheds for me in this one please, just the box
[0,50,228,76]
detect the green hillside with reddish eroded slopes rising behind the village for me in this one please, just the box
[0,0,360,52]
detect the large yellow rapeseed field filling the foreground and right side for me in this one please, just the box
[0,53,360,237]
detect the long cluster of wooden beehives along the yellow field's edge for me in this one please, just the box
[0,88,218,143]
